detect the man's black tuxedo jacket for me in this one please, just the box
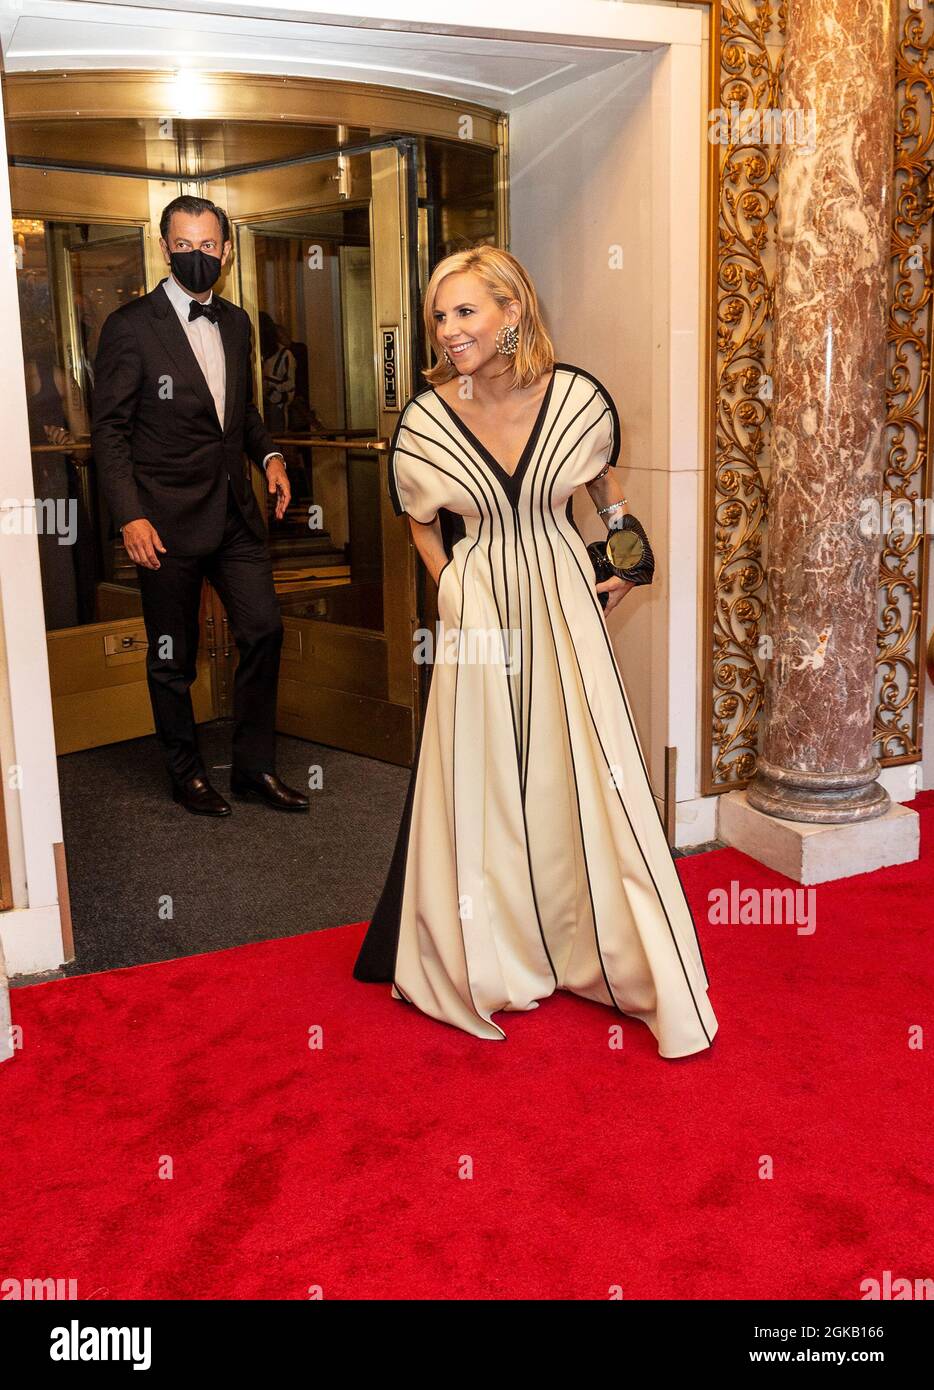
[90,285,275,555]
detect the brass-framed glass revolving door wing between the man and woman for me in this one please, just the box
[236,138,417,763]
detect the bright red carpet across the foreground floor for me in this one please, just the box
[0,794,934,1300]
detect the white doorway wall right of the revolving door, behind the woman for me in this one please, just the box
[510,24,716,844]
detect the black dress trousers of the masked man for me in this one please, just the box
[138,485,282,783]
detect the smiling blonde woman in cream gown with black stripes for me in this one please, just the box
[353,246,717,1058]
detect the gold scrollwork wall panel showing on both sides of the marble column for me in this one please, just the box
[702,0,934,792]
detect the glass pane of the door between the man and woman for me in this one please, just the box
[240,203,382,632]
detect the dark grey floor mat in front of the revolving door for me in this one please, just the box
[15,720,716,984]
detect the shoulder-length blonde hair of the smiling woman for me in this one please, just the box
[423,243,555,388]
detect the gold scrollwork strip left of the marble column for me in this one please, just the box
[703,0,784,792]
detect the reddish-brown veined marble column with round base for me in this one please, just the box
[748,0,895,824]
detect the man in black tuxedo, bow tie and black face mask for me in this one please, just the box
[92,197,309,816]
